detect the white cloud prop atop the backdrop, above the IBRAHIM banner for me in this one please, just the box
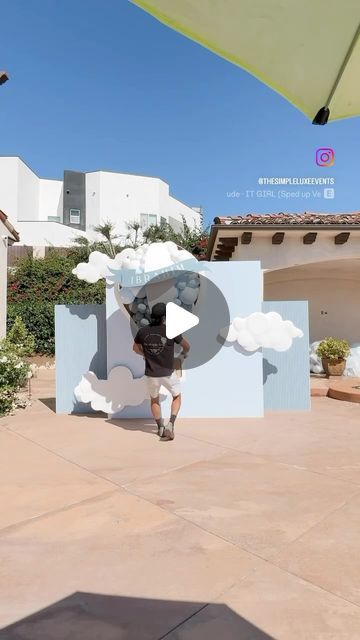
[72,240,193,282]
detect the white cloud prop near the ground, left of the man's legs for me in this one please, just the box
[74,366,148,414]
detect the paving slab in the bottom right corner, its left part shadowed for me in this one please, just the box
[167,566,360,640]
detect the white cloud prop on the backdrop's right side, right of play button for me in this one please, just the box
[220,311,304,351]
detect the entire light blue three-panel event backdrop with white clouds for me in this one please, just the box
[55,255,310,418]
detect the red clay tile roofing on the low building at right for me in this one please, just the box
[214,212,360,225]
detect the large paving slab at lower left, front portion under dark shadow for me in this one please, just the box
[0,489,262,640]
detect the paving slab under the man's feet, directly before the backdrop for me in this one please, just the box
[7,416,226,486]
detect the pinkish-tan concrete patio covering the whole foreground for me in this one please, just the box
[0,370,360,640]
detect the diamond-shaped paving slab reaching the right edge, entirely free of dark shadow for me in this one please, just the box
[130,453,358,558]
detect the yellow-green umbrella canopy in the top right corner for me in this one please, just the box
[131,0,360,124]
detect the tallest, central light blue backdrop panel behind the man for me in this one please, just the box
[106,262,263,418]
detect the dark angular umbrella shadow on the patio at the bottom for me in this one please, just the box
[0,592,275,640]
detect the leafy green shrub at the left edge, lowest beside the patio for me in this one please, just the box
[0,340,30,416]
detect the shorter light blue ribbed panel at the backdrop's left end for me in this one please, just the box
[55,304,106,413]
